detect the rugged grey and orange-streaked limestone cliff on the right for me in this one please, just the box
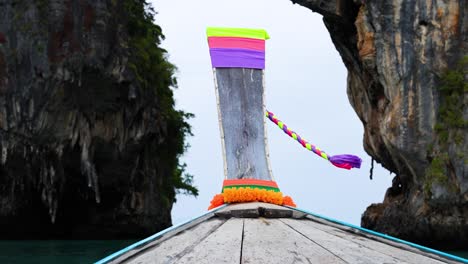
[293,0,468,248]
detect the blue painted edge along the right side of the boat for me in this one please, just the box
[286,206,468,263]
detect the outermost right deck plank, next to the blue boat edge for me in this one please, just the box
[307,215,452,263]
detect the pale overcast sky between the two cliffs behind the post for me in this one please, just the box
[152,0,392,225]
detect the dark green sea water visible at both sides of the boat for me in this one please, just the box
[0,240,468,264]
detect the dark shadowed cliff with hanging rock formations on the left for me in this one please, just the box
[0,0,196,238]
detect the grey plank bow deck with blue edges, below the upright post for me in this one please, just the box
[97,202,466,264]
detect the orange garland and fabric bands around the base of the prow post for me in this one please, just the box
[208,179,296,210]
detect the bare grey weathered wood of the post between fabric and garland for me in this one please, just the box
[214,68,272,180]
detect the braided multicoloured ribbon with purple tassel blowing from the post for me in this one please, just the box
[265,110,362,170]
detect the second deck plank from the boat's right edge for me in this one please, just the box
[281,219,407,264]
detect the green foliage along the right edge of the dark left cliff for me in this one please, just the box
[123,0,198,198]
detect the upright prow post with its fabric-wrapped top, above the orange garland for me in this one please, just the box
[207,28,273,180]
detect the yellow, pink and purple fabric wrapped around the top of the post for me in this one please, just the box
[206,27,270,69]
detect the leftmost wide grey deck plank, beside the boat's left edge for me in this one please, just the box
[125,218,226,264]
